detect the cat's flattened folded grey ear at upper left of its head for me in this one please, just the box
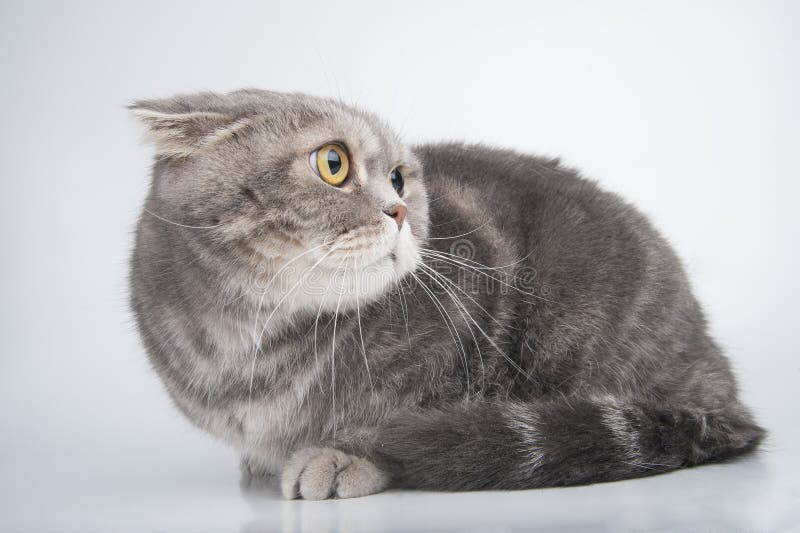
[128,100,248,157]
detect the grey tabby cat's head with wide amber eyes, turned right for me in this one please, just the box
[130,90,428,311]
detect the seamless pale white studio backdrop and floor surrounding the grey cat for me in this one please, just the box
[0,1,800,531]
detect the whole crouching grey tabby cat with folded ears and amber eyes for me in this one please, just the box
[129,89,765,500]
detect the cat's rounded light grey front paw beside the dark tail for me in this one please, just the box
[281,448,389,500]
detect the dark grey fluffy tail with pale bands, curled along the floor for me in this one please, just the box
[375,397,764,490]
